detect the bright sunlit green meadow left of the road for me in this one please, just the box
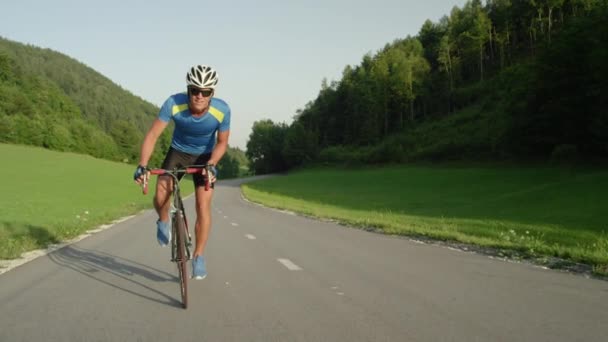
[0,144,191,259]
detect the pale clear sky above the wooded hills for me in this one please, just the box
[0,0,466,150]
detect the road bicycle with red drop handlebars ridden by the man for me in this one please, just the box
[142,164,212,309]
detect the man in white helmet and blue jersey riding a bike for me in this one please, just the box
[133,65,230,279]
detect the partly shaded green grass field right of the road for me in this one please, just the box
[242,166,608,274]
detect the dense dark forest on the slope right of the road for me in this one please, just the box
[247,0,608,173]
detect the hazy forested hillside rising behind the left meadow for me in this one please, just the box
[0,37,170,162]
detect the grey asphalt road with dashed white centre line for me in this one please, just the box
[0,181,608,342]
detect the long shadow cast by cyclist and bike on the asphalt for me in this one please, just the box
[48,246,182,308]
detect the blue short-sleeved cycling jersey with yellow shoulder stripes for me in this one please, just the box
[158,93,230,154]
